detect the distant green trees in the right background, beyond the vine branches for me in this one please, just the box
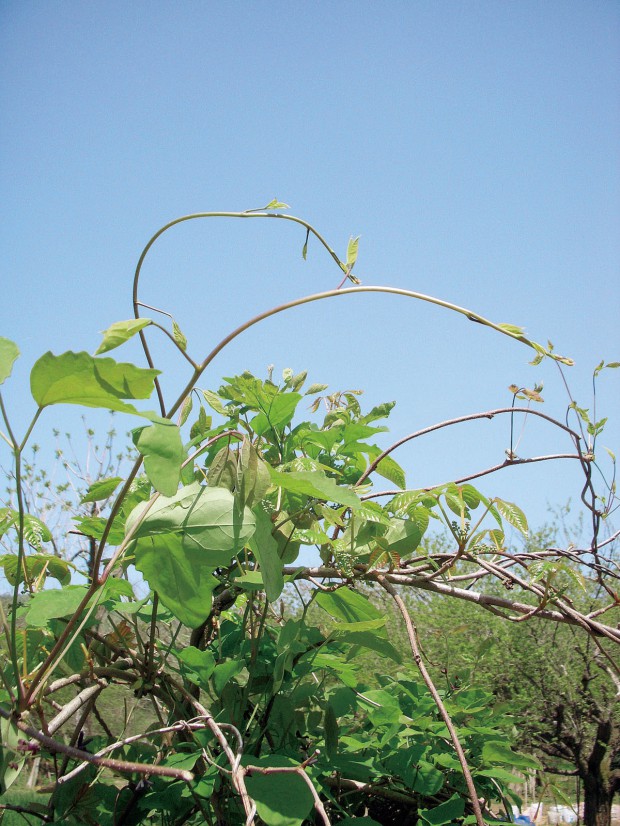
[402,529,620,826]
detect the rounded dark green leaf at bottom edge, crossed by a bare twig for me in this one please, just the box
[242,754,314,826]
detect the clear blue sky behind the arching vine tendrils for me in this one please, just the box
[0,0,620,536]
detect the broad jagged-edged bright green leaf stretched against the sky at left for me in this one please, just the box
[30,352,160,415]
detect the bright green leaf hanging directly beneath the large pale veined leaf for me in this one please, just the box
[135,533,219,628]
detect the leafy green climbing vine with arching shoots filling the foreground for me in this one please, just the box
[0,208,620,826]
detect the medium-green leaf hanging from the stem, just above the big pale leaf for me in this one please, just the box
[131,419,186,496]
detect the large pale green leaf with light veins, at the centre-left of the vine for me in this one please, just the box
[126,482,255,568]
